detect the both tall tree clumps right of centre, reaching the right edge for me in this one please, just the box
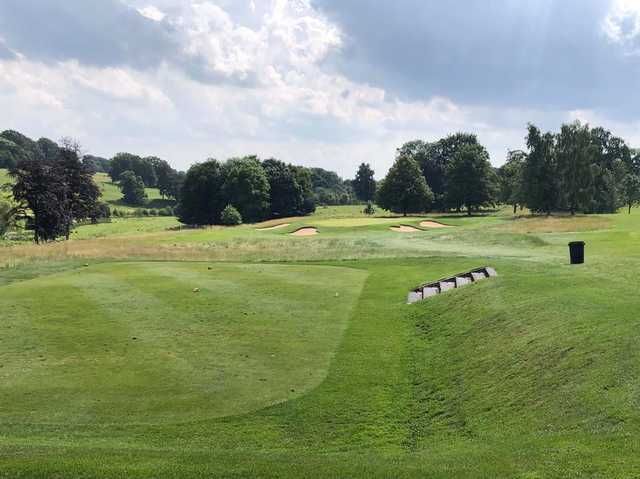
[372,121,640,215]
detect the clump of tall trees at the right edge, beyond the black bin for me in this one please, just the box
[498,121,640,215]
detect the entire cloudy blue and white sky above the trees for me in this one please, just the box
[0,0,640,178]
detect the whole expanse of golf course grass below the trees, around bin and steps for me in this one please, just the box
[0,205,640,478]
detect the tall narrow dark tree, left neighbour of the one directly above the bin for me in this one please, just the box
[522,124,559,215]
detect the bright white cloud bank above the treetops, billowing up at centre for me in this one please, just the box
[0,0,640,176]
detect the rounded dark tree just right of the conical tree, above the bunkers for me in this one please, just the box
[447,144,495,215]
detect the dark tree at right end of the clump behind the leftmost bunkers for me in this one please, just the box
[262,159,304,218]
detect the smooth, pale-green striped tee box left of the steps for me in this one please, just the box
[0,263,365,424]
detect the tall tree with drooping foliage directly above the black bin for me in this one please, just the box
[555,122,598,215]
